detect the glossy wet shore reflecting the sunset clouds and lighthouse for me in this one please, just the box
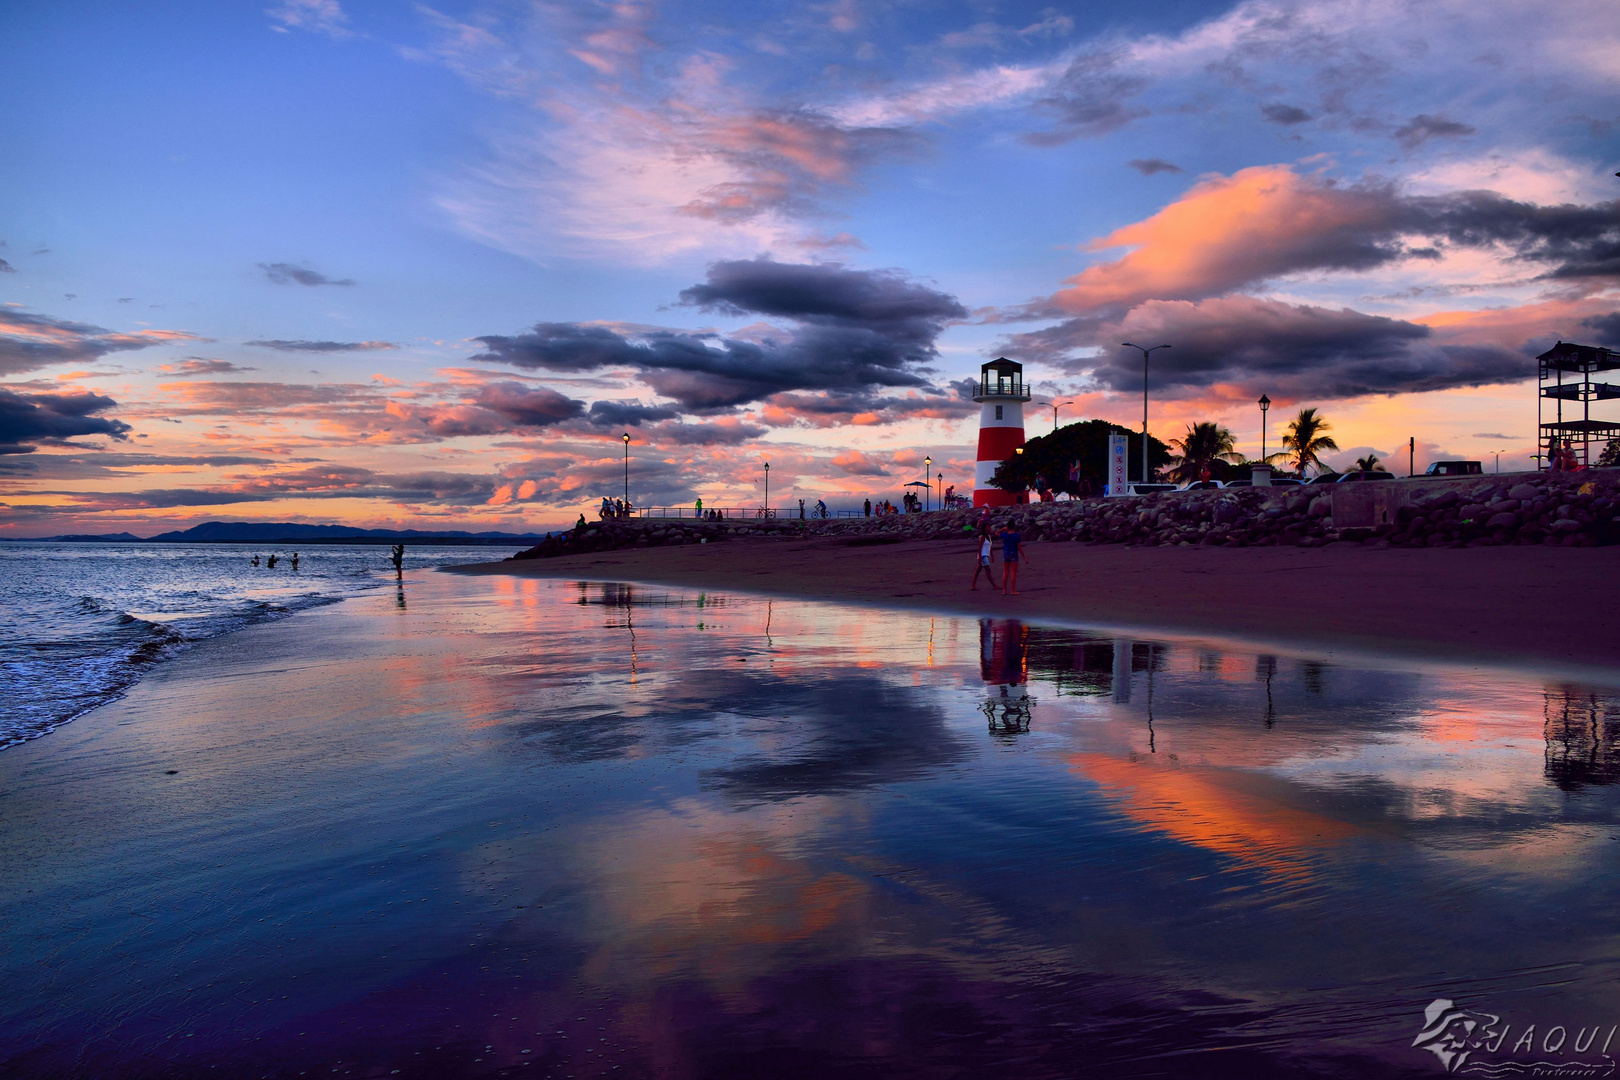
[0,573,1620,1080]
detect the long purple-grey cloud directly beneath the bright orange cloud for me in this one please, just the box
[1008,296,1534,400]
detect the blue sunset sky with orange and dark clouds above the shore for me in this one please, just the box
[0,0,1620,538]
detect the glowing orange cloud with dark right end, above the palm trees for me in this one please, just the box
[1030,165,1620,317]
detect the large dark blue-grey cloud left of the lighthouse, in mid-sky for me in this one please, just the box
[473,257,967,413]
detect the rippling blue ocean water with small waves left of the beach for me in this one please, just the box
[0,541,518,750]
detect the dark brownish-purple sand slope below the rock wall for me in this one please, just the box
[454,539,1620,669]
